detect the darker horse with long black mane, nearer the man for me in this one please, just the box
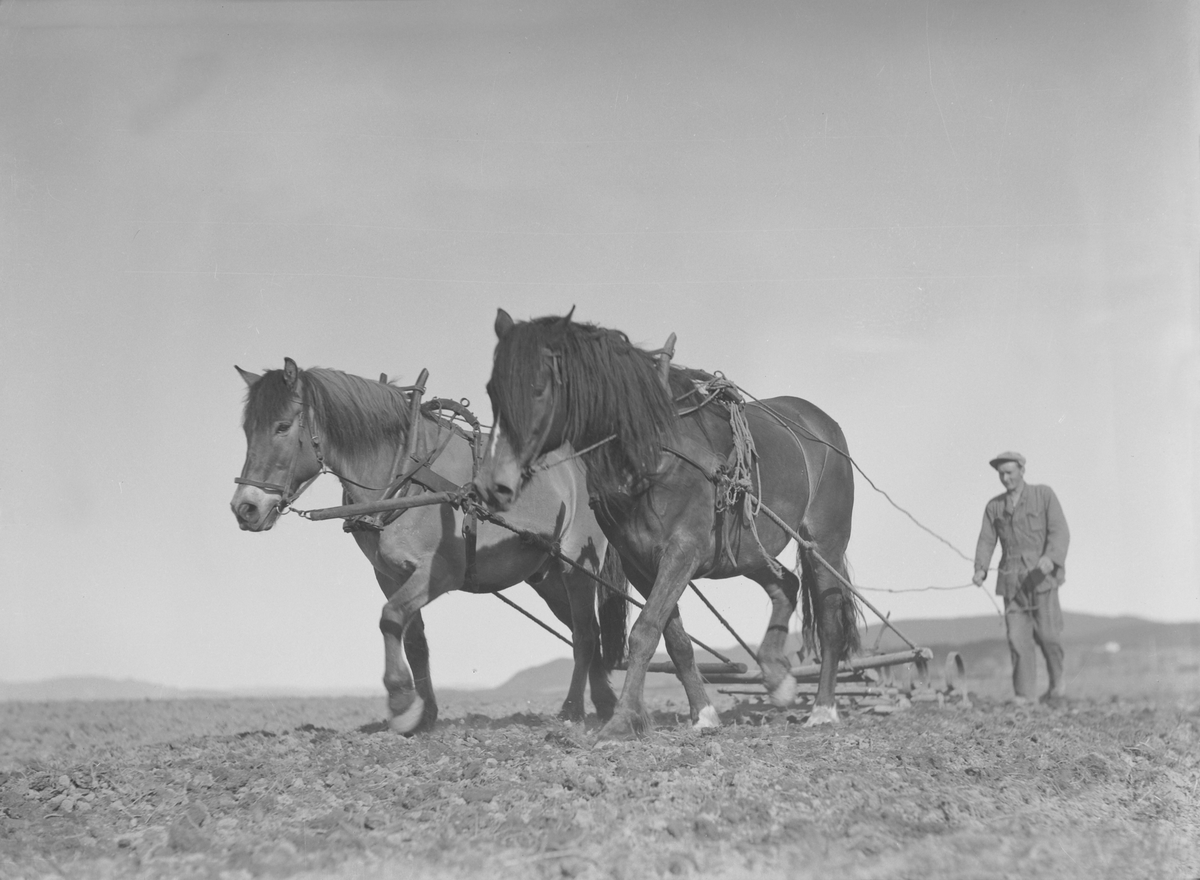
[475,310,859,740]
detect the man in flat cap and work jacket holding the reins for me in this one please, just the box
[972,453,1070,704]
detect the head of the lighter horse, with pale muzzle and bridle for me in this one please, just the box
[229,358,322,532]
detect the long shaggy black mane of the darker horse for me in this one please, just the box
[488,317,708,497]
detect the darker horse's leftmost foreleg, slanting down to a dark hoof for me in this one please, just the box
[598,544,707,744]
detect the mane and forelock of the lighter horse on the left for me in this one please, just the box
[242,367,409,457]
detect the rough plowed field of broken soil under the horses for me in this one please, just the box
[0,699,1200,880]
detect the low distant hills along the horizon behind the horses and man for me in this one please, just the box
[0,612,1200,702]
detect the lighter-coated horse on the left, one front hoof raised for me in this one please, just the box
[230,358,625,734]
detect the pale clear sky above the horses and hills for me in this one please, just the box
[0,0,1200,694]
